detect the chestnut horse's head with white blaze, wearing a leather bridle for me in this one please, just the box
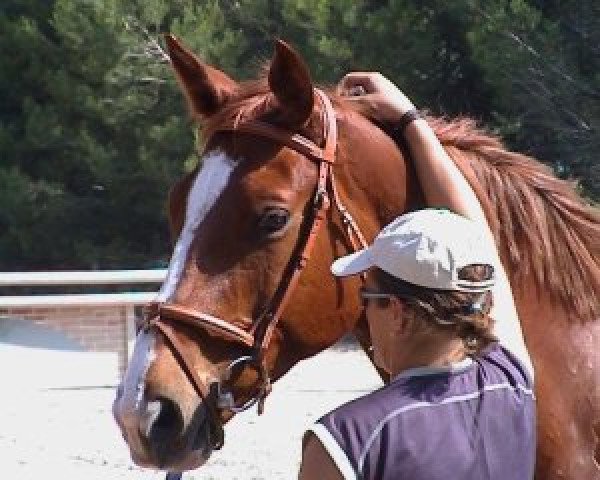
[113,37,416,471]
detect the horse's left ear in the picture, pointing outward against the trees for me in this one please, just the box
[165,34,237,117]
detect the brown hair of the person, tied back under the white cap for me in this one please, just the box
[375,265,497,355]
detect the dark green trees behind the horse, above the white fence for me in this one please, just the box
[0,0,600,270]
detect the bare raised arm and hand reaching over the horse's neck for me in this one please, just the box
[339,72,533,375]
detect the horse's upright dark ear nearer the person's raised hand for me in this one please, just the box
[269,40,315,126]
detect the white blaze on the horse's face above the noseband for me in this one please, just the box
[156,150,236,302]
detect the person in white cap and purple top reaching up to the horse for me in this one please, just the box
[299,73,535,480]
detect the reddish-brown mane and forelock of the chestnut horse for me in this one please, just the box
[202,79,600,320]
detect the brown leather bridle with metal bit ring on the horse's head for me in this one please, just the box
[144,89,367,449]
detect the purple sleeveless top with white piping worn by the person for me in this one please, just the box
[310,343,536,480]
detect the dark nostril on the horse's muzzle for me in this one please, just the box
[140,397,183,448]
